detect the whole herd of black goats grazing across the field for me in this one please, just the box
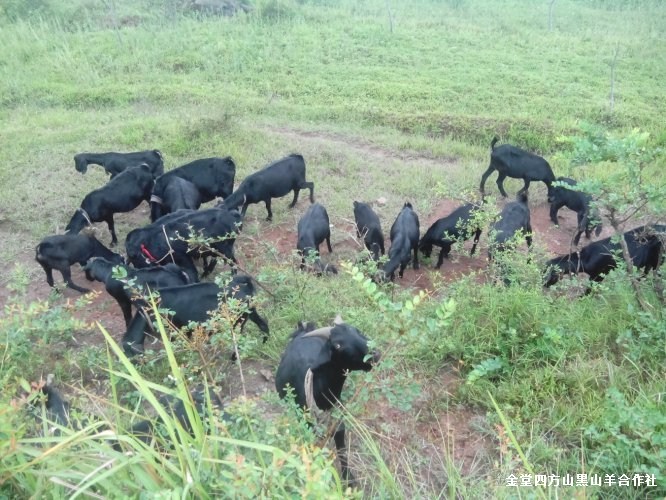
[29,138,666,478]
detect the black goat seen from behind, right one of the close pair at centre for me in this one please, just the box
[383,202,420,281]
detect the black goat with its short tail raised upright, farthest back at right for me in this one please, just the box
[480,137,555,198]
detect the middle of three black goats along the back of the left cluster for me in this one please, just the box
[150,156,236,222]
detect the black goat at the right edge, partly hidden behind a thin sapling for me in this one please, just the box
[545,224,666,293]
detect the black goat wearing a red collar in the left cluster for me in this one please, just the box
[125,207,240,283]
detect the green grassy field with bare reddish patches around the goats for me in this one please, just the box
[0,0,666,498]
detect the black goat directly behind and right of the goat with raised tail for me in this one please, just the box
[548,177,602,246]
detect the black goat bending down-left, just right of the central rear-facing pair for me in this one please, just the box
[419,203,481,269]
